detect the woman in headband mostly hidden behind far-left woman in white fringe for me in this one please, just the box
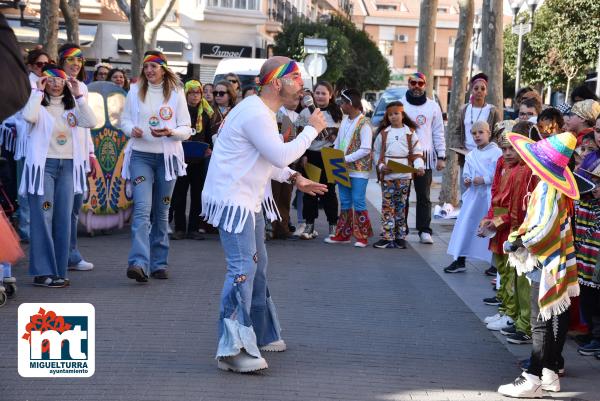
[58,43,97,271]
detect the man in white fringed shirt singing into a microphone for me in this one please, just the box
[202,56,327,373]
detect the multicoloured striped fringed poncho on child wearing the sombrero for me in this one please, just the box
[508,181,579,320]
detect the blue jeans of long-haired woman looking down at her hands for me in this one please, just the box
[127,150,175,275]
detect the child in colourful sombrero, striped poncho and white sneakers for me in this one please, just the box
[498,132,579,398]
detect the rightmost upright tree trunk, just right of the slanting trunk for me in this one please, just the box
[481,0,504,110]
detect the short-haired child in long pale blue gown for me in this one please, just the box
[444,121,502,273]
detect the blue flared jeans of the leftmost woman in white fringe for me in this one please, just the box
[24,159,74,278]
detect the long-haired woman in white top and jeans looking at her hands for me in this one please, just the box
[121,50,192,282]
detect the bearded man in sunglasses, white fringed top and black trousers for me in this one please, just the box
[401,72,446,244]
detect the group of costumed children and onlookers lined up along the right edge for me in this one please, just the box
[436,74,600,398]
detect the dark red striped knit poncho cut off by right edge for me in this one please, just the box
[575,199,600,289]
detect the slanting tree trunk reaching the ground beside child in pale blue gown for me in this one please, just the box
[440,0,475,206]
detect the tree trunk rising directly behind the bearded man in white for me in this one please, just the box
[417,0,438,98]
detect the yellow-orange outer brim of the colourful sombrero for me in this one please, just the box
[507,132,579,200]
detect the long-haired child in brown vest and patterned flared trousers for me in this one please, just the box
[373,102,425,249]
